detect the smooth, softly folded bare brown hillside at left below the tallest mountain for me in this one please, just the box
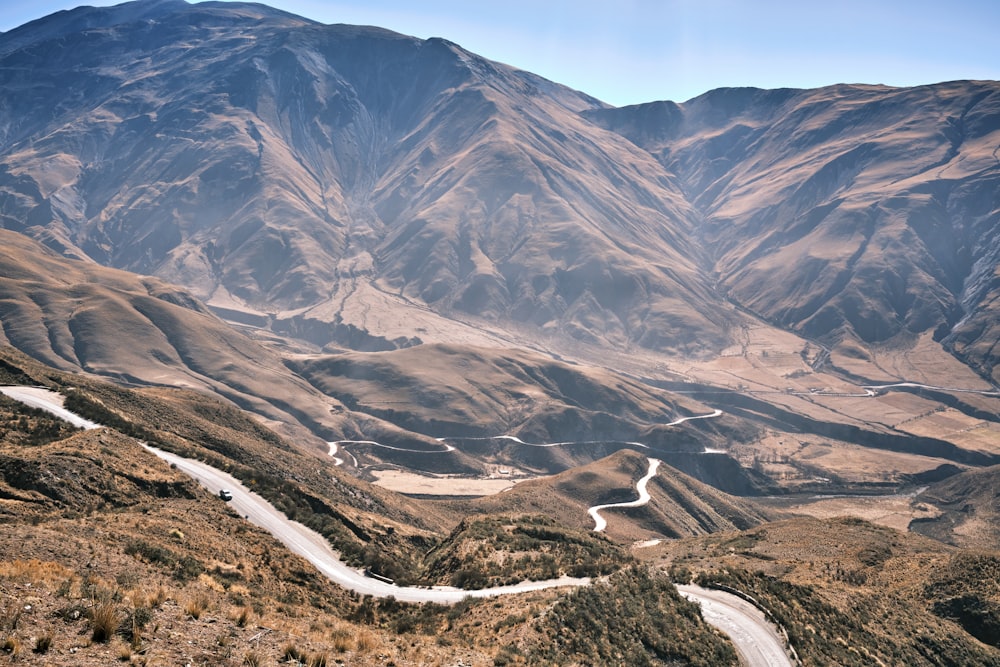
[0,230,346,439]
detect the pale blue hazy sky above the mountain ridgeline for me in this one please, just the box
[0,0,1000,105]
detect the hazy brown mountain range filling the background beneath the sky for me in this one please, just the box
[0,0,1000,377]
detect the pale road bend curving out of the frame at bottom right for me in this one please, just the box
[677,585,794,667]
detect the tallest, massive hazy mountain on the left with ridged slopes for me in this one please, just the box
[0,0,736,352]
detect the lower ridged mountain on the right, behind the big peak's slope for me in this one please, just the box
[586,82,1000,374]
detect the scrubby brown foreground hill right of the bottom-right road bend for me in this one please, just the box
[643,518,1000,667]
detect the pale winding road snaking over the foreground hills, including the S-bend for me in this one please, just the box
[0,387,792,667]
